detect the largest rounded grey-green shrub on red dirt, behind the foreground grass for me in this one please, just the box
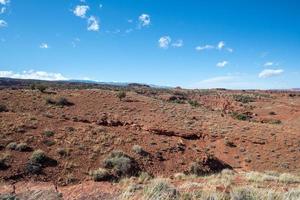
[104,151,140,177]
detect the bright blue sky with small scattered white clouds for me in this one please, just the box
[0,0,300,89]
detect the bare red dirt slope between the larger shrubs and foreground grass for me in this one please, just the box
[0,89,300,185]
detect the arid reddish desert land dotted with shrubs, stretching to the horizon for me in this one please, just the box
[0,79,300,199]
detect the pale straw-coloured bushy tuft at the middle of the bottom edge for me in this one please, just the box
[144,179,180,200]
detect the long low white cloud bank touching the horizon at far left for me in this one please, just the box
[0,70,68,81]
